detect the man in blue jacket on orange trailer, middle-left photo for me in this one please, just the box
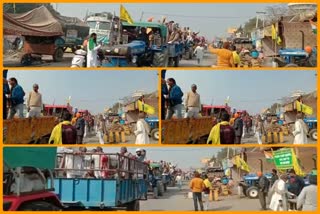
[8,77,25,119]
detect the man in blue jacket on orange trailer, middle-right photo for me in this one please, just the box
[164,78,183,120]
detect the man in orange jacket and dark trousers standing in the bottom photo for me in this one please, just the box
[189,172,205,211]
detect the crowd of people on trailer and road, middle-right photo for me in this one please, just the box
[161,78,308,145]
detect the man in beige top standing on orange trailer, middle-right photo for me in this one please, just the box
[185,84,201,118]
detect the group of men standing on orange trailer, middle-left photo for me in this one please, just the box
[3,74,43,119]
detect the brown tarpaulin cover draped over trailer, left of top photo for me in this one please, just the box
[3,6,63,36]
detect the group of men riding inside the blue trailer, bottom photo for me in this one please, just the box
[59,147,146,179]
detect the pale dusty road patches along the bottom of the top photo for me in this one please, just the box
[4,52,216,67]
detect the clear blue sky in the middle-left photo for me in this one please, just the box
[8,70,158,113]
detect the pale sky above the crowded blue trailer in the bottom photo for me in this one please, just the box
[58,147,221,169]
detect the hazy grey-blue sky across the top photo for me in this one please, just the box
[53,3,275,39]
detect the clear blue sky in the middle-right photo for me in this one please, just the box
[166,70,316,114]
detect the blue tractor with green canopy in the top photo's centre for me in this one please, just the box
[102,22,183,67]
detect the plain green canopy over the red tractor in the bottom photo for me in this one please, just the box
[3,147,57,169]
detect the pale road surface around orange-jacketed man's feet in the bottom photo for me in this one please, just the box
[140,184,260,211]
